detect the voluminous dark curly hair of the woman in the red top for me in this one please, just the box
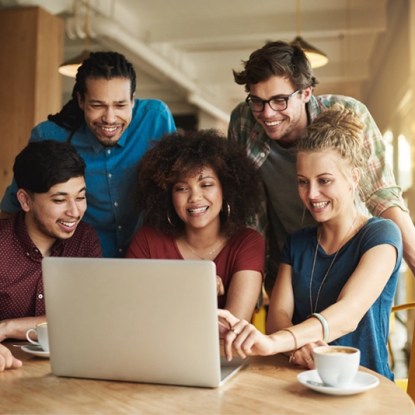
[137,130,261,236]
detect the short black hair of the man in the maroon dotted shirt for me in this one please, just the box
[13,140,85,193]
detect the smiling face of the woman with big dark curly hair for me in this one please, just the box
[172,166,223,234]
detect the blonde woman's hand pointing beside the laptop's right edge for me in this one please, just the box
[218,310,275,360]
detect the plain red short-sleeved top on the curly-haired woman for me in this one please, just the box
[126,226,265,308]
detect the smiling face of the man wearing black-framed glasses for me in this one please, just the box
[249,76,311,145]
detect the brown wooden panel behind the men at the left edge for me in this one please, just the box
[0,7,64,205]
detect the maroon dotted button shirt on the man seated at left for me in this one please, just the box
[0,213,101,320]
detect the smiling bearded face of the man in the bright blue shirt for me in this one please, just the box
[78,78,134,147]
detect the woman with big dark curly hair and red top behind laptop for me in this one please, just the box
[126,130,265,320]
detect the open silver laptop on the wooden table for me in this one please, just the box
[42,257,246,387]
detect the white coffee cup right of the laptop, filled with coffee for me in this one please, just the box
[313,346,360,388]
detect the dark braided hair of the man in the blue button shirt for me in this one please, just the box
[48,52,136,131]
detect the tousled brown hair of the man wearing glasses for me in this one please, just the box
[233,40,317,92]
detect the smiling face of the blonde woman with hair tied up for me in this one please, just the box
[297,150,359,222]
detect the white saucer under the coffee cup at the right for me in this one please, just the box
[297,370,379,395]
